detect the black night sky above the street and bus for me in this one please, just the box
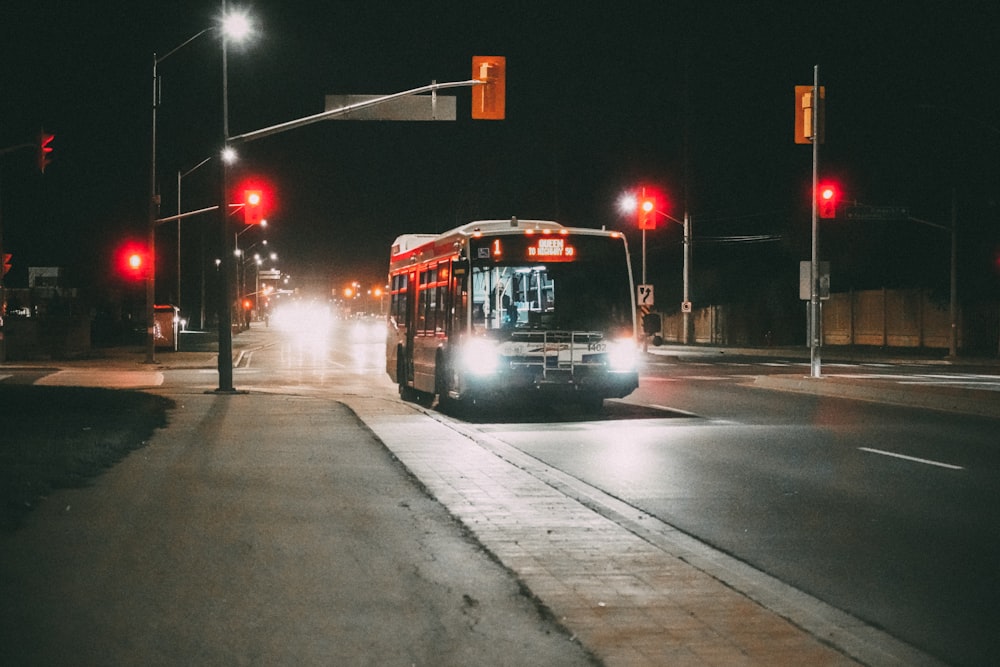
[0,0,1000,316]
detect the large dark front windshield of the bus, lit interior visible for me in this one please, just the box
[468,238,632,333]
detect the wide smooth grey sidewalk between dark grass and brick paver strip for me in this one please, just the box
[0,391,596,666]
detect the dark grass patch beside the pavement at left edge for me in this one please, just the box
[0,385,173,531]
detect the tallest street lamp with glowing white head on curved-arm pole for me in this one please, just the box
[146,7,249,364]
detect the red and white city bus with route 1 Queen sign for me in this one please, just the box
[385,218,639,411]
